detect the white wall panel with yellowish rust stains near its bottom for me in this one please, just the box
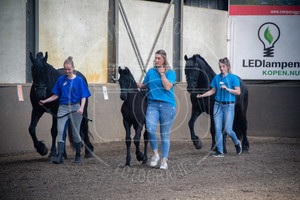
[39,0,108,83]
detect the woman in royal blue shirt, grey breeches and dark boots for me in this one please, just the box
[39,56,91,164]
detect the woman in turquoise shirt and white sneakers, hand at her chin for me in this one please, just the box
[139,50,176,169]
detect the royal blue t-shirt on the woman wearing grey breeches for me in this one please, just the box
[52,75,91,105]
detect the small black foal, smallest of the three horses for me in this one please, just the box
[118,67,148,166]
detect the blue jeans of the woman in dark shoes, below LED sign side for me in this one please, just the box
[214,102,238,152]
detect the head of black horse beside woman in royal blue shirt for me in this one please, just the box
[30,52,48,99]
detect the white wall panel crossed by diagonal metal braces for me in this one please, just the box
[119,0,174,81]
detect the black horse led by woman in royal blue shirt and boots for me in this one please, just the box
[29,52,94,159]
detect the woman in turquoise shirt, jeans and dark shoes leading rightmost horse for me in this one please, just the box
[197,57,242,157]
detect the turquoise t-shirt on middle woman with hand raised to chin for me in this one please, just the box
[143,67,176,107]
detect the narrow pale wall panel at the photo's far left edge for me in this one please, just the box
[0,0,26,83]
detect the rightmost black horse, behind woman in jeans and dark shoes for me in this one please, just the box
[184,54,249,152]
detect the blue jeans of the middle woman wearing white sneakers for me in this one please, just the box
[146,100,176,159]
